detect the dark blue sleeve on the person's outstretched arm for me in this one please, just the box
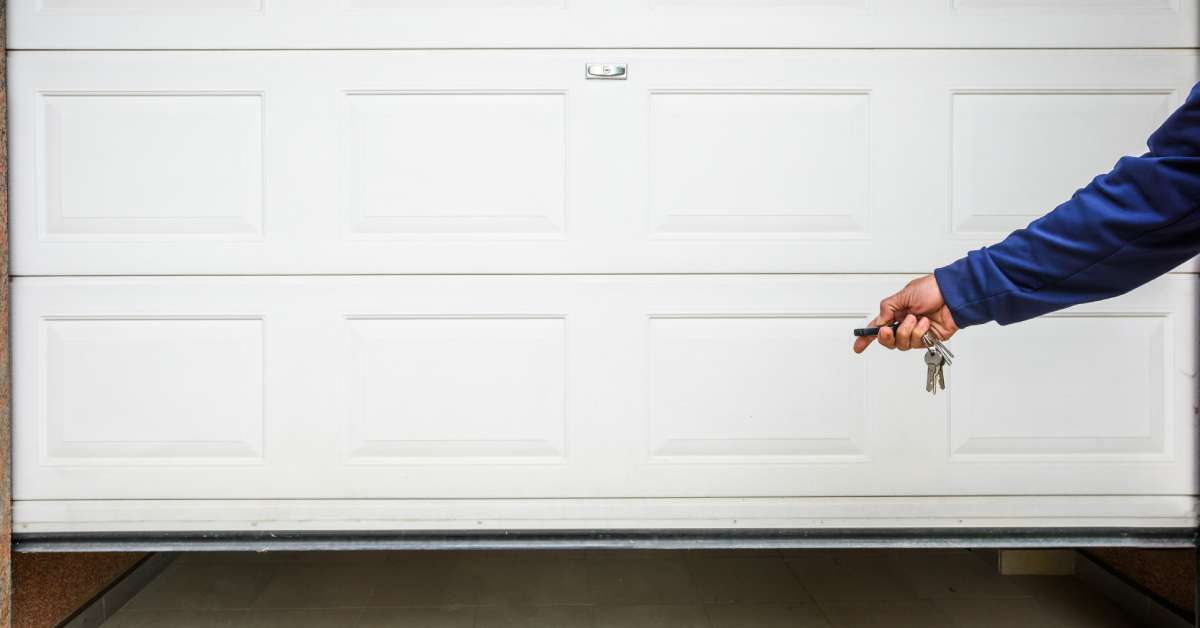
[935,84,1200,328]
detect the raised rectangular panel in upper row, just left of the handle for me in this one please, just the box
[347,92,566,237]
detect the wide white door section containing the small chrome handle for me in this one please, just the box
[10,50,1196,275]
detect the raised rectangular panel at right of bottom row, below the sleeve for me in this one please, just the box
[949,315,1166,460]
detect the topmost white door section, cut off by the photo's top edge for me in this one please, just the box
[8,0,1196,49]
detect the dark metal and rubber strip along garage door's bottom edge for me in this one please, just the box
[13,527,1200,554]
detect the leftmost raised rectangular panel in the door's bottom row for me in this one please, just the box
[38,318,264,465]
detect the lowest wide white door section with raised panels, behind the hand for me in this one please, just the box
[13,276,1196,500]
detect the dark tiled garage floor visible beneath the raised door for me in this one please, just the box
[106,550,1152,628]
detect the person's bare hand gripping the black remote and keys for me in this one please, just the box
[854,275,959,353]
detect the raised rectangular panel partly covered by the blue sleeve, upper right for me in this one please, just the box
[950,90,1174,232]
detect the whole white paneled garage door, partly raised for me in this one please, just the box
[10,0,1200,532]
